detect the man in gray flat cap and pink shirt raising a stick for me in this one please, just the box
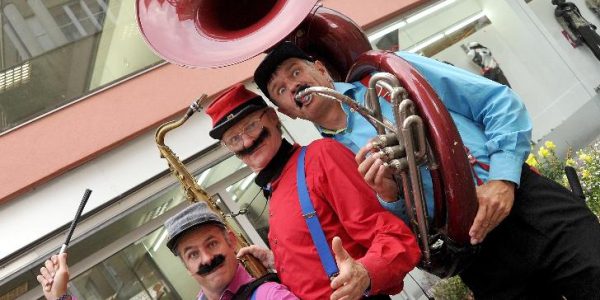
[38,202,298,300]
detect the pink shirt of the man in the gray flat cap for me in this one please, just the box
[198,265,298,300]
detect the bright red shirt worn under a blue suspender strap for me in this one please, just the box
[269,139,420,299]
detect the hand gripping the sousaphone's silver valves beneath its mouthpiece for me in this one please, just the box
[354,142,398,202]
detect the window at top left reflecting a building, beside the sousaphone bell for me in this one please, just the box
[0,0,160,132]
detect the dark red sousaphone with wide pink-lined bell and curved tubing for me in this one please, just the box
[136,0,477,277]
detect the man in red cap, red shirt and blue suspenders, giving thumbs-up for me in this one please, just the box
[206,84,420,300]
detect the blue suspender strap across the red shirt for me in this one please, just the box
[296,147,339,279]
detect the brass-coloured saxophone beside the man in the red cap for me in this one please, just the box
[154,94,268,278]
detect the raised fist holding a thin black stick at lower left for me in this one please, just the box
[37,253,69,300]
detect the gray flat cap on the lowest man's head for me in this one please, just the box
[165,202,225,256]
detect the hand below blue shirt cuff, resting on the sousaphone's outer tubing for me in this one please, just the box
[469,180,515,245]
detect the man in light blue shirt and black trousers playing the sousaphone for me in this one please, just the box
[254,42,600,299]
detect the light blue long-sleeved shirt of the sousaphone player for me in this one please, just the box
[319,52,532,219]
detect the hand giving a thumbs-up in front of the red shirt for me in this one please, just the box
[329,236,371,300]
